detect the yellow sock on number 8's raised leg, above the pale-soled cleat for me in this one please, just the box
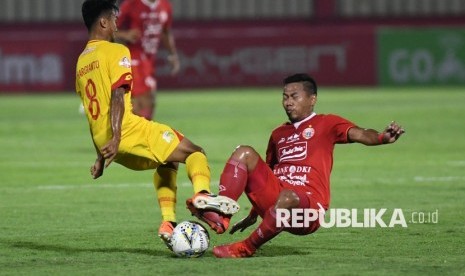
[186,151,210,193]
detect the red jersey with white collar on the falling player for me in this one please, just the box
[266,113,355,208]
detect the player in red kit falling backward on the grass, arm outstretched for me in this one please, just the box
[189,74,404,258]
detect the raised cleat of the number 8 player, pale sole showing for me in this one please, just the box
[187,193,240,215]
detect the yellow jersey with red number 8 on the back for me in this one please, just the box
[76,40,145,148]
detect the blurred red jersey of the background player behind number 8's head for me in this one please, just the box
[118,0,173,60]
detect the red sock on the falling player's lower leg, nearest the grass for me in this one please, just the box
[244,206,282,249]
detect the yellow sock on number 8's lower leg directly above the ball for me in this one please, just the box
[153,166,178,222]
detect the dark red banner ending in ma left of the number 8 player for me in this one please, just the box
[0,24,85,92]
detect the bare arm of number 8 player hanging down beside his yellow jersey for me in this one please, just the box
[101,87,126,168]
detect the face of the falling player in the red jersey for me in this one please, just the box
[283,82,316,123]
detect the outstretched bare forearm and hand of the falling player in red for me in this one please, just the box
[347,122,405,146]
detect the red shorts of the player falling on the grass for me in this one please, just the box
[245,159,321,235]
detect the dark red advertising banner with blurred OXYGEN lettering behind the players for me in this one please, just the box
[158,23,376,88]
